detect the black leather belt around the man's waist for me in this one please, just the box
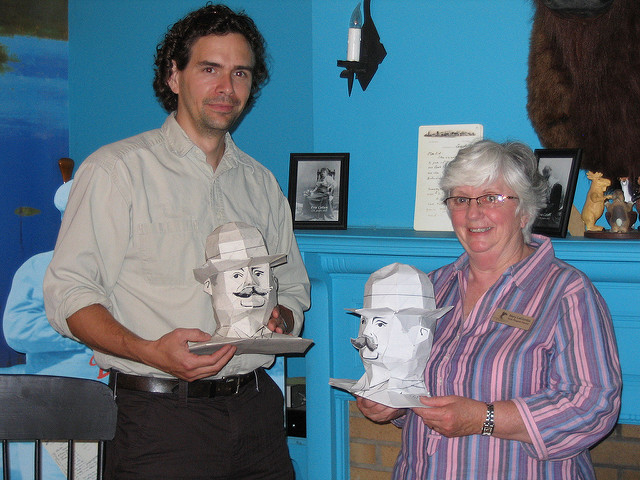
[109,371,256,398]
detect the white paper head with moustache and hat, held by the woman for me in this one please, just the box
[349,263,452,395]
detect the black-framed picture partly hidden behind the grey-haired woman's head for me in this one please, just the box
[532,148,582,238]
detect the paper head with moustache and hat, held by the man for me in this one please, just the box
[193,222,287,338]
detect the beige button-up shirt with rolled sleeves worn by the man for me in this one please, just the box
[44,115,309,377]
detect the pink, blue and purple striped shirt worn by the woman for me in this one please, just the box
[393,235,622,480]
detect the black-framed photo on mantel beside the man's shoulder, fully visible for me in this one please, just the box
[289,153,349,229]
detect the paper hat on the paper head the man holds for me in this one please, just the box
[193,222,287,283]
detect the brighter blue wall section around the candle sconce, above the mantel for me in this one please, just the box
[313,0,537,227]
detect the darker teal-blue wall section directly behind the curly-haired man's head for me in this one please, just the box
[69,0,313,185]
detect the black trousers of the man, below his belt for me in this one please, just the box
[105,369,295,480]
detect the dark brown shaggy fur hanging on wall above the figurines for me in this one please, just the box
[527,0,640,178]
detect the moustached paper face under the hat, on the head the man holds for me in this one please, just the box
[205,263,277,337]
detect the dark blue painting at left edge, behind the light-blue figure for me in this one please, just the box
[0,0,69,367]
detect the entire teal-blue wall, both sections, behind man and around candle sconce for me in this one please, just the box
[69,0,539,228]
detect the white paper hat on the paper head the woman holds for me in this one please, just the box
[348,263,451,316]
